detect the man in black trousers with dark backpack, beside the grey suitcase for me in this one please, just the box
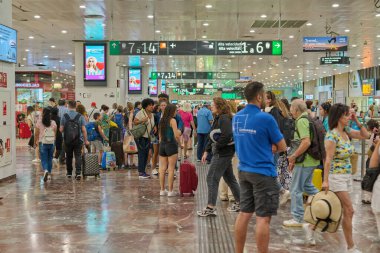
[60,101,90,180]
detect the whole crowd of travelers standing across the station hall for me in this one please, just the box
[20,82,380,253]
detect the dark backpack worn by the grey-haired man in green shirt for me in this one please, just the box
[298,116,326,161]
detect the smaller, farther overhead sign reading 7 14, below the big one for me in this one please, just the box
[150,72,240,80]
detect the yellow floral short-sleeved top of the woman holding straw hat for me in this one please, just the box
[325,129,354,174]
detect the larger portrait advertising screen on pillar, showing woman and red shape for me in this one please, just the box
[84,44,107,81]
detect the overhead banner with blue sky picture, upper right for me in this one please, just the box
[303,36,348,52]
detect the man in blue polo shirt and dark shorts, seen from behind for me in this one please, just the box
[232,82,286,253]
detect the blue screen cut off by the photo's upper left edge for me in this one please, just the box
[0,25,17,63]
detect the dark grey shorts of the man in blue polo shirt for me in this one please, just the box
[239,171,280,217]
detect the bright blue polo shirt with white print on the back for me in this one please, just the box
[232,104,284,177]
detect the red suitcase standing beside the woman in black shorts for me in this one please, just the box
[179,161,198,197]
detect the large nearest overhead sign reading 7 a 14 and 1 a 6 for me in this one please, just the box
[109,40,282,55]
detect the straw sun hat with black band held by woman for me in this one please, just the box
[304,191,342,233]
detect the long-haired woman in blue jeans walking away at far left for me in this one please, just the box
[35,108,57,182]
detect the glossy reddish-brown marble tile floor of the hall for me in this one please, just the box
[0,143,380,253]
